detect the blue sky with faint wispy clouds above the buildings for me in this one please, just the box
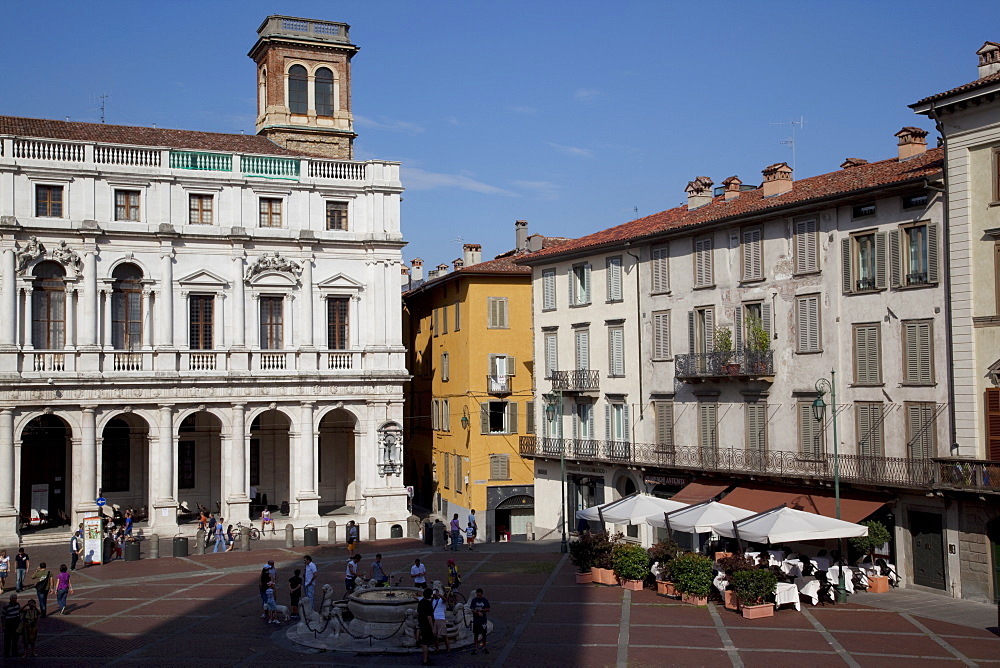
[0,0,1000,266]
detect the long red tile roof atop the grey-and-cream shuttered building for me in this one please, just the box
[518,148,944,264]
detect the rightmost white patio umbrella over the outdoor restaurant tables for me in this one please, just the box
[712,506,868,544]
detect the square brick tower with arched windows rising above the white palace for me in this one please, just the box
[247,15,358,160]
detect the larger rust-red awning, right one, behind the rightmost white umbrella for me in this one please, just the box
[720,485,888,522]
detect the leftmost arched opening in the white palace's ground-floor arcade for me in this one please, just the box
[20,415,73,526]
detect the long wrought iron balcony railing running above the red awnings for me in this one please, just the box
[519,436,1000,492]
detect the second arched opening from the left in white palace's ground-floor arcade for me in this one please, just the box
[98,413,149,518]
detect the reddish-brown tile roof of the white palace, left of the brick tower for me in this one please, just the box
[0,116,302,156]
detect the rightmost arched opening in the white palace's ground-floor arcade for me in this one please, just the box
[317,408,357,515]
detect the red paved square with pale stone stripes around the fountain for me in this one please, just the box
[4,539,1000,668]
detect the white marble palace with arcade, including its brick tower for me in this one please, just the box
[0,16,408,545]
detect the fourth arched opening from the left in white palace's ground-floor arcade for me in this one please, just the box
[250,410,294,514]
